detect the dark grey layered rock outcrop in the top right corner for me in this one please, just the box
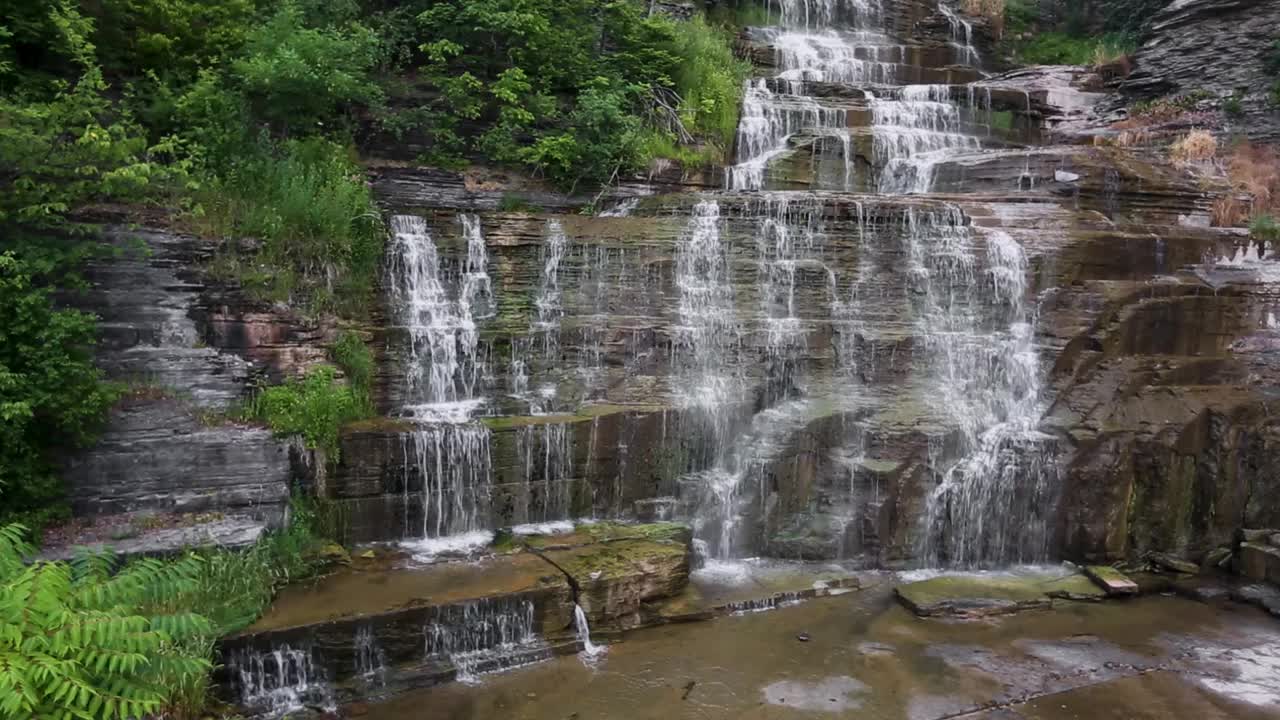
[1121,0,1280,141]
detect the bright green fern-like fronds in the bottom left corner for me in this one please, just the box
[0,525,214,720]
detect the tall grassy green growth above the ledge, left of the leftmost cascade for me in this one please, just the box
[198,140,385,314]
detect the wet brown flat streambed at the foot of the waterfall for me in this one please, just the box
[355,585,1280,720]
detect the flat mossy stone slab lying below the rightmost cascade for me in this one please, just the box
[893,573,1105,618]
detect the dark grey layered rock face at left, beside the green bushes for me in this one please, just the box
[65,229,309,523]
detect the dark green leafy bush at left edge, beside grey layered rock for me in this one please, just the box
[0,252,118,525]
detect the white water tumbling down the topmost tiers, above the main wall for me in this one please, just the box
[726,0,980,193]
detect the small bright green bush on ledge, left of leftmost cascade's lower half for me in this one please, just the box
[250,366,369,460]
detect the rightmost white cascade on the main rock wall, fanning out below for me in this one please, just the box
[924,225,1057,566]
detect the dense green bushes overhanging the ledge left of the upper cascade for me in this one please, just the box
[381,0,748,188]
